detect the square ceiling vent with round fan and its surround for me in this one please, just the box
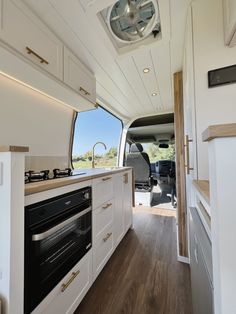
[100,0,161,53]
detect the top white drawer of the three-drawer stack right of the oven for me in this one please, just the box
[93,175,113,209]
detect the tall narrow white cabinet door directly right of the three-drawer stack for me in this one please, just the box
[114,173,125,247]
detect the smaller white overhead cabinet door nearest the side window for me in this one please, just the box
[64,47,96,104]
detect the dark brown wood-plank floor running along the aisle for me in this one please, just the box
[75,210,192,314]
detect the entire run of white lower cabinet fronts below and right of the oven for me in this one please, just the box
[32,170,132,314]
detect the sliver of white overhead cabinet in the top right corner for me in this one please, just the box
[223,0,236,47]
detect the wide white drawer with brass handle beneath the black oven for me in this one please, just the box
[32,250,92,314]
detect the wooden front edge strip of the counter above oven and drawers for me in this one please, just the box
[25,167,132,196]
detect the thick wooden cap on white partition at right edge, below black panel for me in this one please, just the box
[202,123,236,142]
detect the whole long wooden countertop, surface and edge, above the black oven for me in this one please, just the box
[25,167,132,195]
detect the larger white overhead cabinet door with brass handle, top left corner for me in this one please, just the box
[0,0,63,80]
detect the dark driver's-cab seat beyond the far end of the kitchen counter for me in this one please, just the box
[126,143,152,189]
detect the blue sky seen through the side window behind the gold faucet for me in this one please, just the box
[73,108,122,156]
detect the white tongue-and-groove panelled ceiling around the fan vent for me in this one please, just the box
[24,0,190,121]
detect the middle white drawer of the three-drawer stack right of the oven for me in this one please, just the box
[93,200,114,239]
